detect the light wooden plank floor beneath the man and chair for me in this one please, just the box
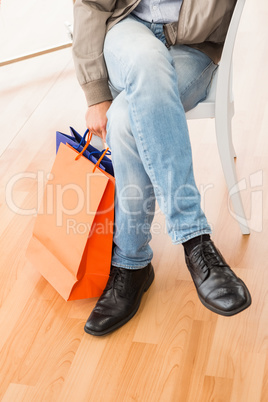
[0,0,268,402]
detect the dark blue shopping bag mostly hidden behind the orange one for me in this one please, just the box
[56,127,114,176]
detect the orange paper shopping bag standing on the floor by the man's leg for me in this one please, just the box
[27,140,115,300]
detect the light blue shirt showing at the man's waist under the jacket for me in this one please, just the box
[132,0,183,24]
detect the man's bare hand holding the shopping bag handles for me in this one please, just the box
[86,101,112,141]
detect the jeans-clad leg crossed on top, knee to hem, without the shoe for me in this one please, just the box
[104,18,211,243]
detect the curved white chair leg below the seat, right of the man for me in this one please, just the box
[215,108,250,234]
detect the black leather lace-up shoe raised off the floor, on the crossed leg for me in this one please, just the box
[185,240,251,316]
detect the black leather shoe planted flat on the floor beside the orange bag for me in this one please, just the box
[84,264,154,336]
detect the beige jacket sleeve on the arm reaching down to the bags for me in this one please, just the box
[72,0,116,106]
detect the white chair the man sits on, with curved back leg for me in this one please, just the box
[186,0,250,234]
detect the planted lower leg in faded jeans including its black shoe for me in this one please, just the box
[85,92,155,336]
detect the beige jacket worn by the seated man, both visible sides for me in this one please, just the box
[73,0,236,106]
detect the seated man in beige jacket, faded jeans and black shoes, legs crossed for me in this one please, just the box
[73,0,251,336]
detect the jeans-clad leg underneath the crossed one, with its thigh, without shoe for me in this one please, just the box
[104,29,216,268]
